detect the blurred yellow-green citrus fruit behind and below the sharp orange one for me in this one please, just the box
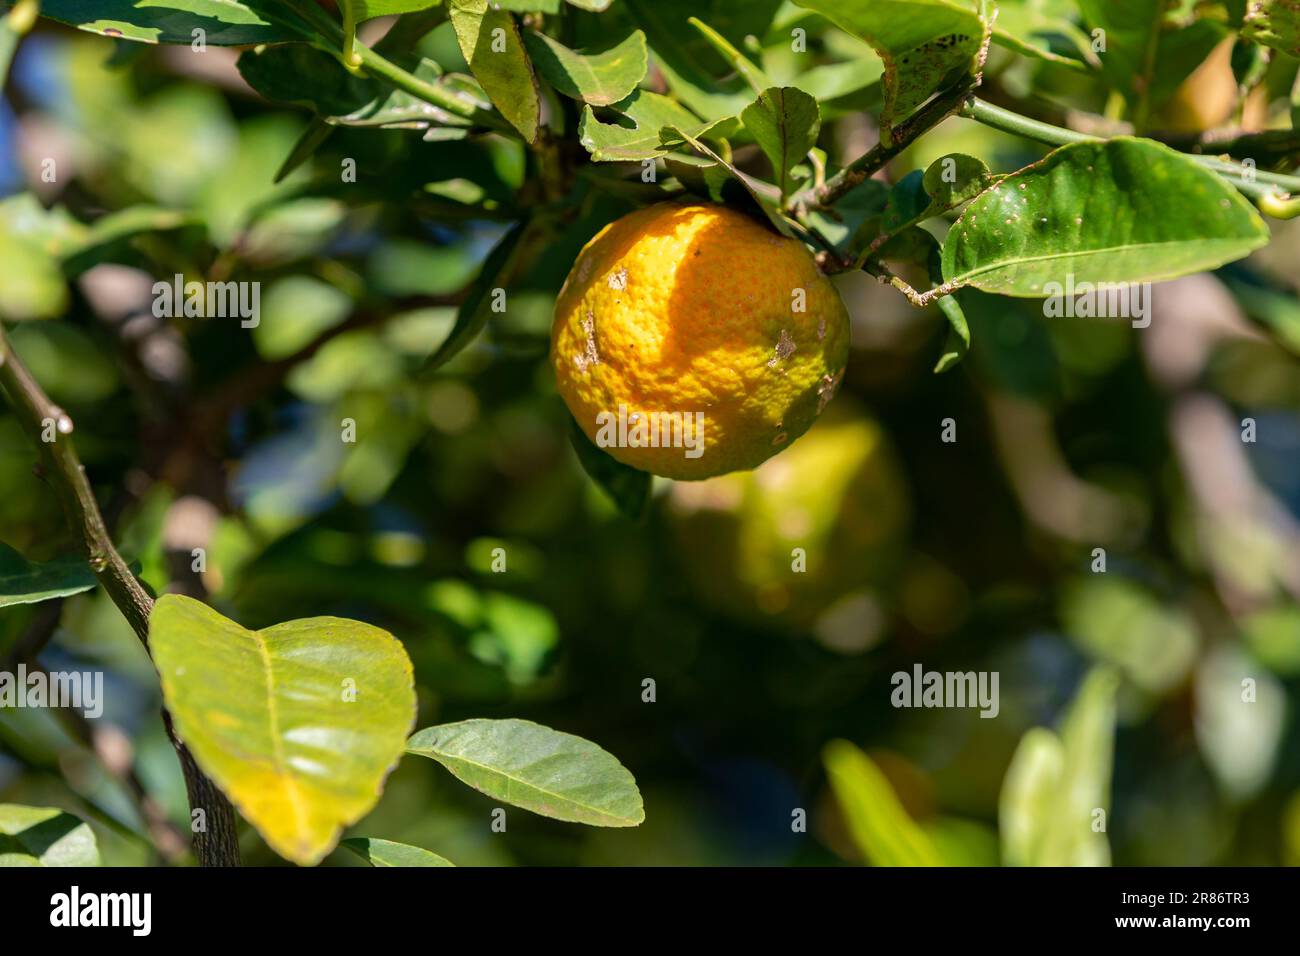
[668,401,910,627]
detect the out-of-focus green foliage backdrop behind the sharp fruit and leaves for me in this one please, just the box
[0,1,1300,865]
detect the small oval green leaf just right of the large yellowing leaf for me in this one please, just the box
[407,719,645,826]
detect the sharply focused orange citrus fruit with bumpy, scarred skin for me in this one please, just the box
[551,203,849,479]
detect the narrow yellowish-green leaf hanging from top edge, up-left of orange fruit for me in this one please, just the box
[450,0,541,143]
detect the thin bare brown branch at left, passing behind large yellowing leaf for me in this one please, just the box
[0,325,239,866]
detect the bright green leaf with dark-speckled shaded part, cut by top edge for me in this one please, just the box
[794,0,987,134]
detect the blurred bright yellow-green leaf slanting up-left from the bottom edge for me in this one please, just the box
[822,740,943,866]
